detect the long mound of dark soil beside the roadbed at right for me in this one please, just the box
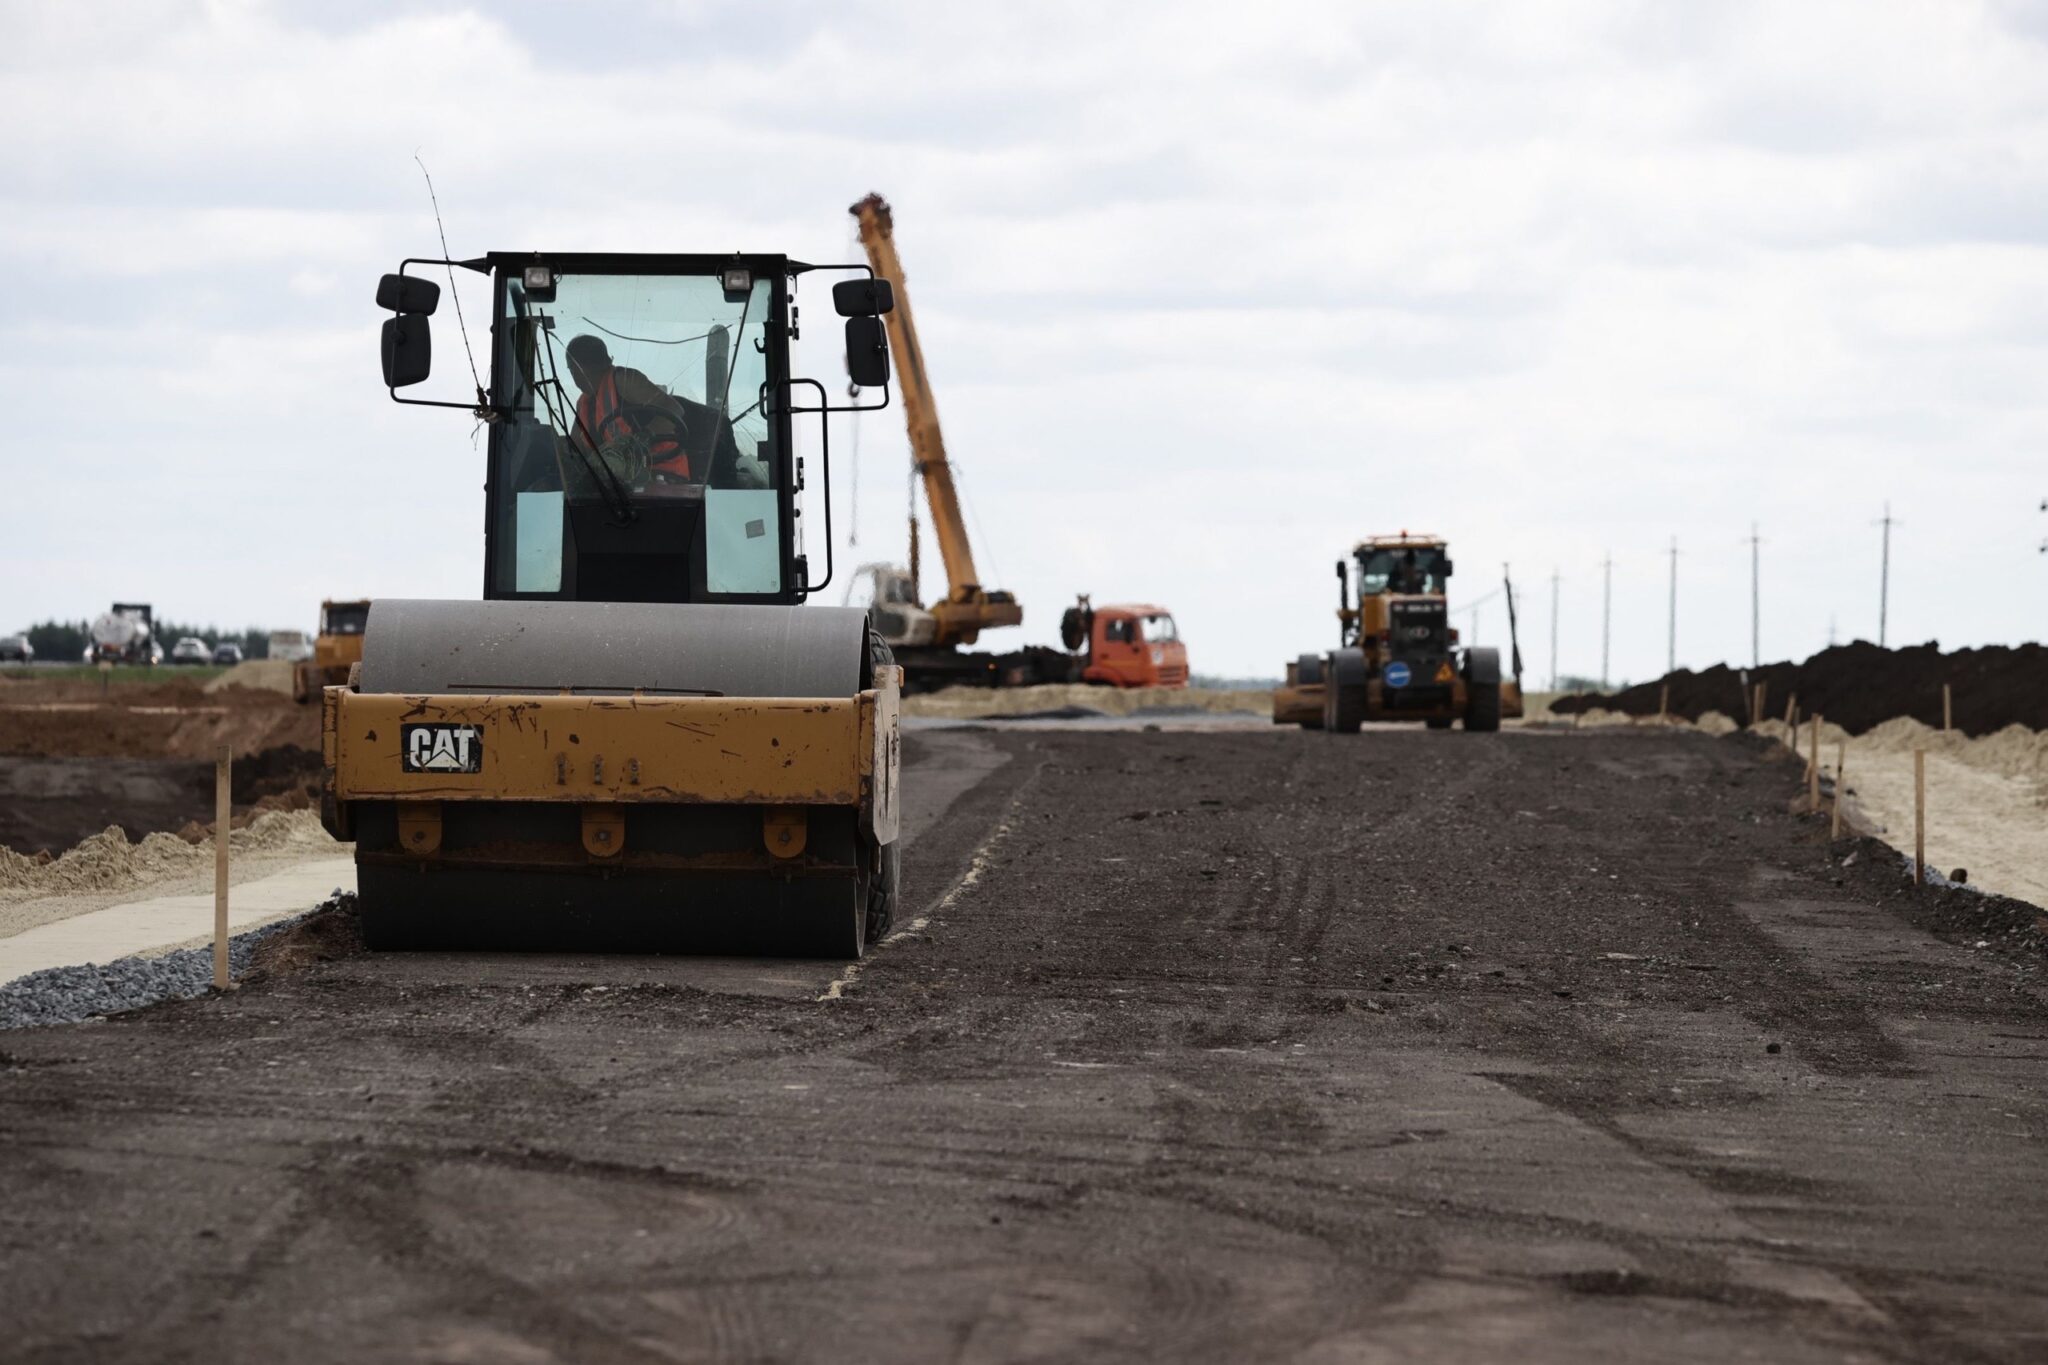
[1550,641,2048,735]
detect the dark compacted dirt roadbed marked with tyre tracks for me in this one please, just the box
[0,731,2048,1363]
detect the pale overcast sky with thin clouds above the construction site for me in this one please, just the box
[0,0,2048,681]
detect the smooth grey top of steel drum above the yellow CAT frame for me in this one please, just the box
[358,598,868,698]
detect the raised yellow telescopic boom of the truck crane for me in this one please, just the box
[848,194,1024,645]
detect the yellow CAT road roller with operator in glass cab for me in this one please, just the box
[322,252,901,958]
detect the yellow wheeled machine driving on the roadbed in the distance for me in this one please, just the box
[1274,530,1522,735]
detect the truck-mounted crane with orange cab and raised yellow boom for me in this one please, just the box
[848,194,1188,690]
